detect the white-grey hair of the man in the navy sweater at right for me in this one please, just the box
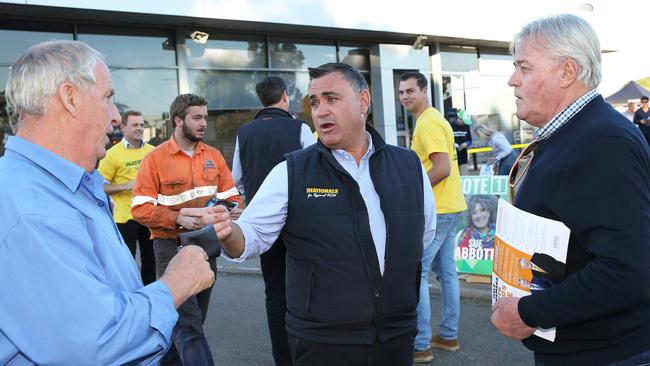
[510,14,602,88]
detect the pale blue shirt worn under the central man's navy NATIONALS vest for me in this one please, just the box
[224,132,436,274]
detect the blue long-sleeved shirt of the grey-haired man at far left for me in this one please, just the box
[0,136,178,365]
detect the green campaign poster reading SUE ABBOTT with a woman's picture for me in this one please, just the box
[454,175,509,276]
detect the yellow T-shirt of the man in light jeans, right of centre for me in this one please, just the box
[411,107,467,214]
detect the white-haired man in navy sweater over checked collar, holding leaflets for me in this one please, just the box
[492,14,650,366]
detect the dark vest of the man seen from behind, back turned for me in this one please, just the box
[237,108,304,203]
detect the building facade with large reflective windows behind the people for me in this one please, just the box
[0,0,532,163]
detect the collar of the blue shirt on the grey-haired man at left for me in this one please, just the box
[5,136,90,192]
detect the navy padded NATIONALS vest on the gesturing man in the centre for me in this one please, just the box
[282,127,422,344]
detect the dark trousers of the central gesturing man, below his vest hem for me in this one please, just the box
[289,334,415,366]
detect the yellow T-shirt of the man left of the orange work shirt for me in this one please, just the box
[97,139,154,224]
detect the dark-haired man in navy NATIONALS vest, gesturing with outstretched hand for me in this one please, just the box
[190,63,435,366]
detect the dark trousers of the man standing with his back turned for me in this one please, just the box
[260,239,293,366]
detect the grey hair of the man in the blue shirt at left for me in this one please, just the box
[5,41,103,128]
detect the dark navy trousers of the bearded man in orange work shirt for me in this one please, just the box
[153,239,216,366]
